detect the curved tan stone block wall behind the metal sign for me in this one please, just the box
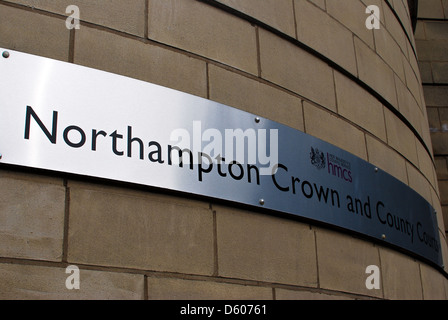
[0,0,448,299]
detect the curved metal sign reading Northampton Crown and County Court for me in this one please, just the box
[0,49,442,266]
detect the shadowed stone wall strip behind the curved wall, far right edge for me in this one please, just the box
[415,0,448,248]
